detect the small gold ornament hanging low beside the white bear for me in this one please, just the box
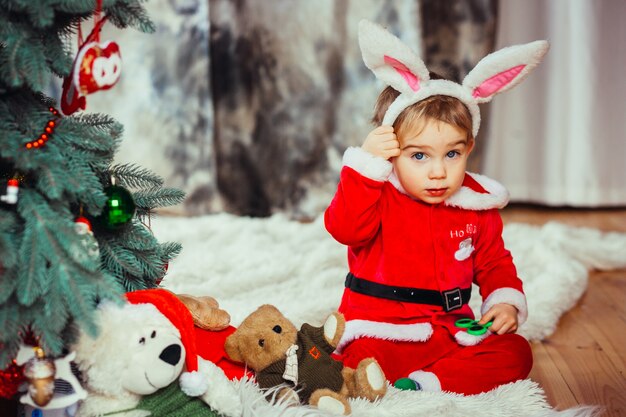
[24,347,56,407]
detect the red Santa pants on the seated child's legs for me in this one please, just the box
[336,328,533,395]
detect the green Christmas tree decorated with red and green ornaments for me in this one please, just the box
[0,0,183,397]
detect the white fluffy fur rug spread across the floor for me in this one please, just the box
[152,214,626,417]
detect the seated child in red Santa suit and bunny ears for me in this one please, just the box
[325,21,548,394]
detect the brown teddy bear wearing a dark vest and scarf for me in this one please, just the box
[225,304,387,414]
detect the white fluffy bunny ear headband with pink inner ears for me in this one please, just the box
[359,20,549,137]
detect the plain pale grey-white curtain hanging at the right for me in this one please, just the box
[482,0,626,207]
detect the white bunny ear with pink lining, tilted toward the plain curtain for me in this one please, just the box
[463,41,549,103]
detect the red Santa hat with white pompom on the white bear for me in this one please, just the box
[126,288,209,397]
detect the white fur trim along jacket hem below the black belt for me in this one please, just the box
[335,320,433,353]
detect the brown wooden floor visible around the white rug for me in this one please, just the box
[502,206,626,417]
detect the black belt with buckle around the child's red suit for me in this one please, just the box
[346,272,472,312]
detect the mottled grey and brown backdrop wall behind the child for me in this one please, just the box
[87,0,497,219]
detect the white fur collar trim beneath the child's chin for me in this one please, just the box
[445,172,509,210]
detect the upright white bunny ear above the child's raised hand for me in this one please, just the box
[359,20,429,93]
